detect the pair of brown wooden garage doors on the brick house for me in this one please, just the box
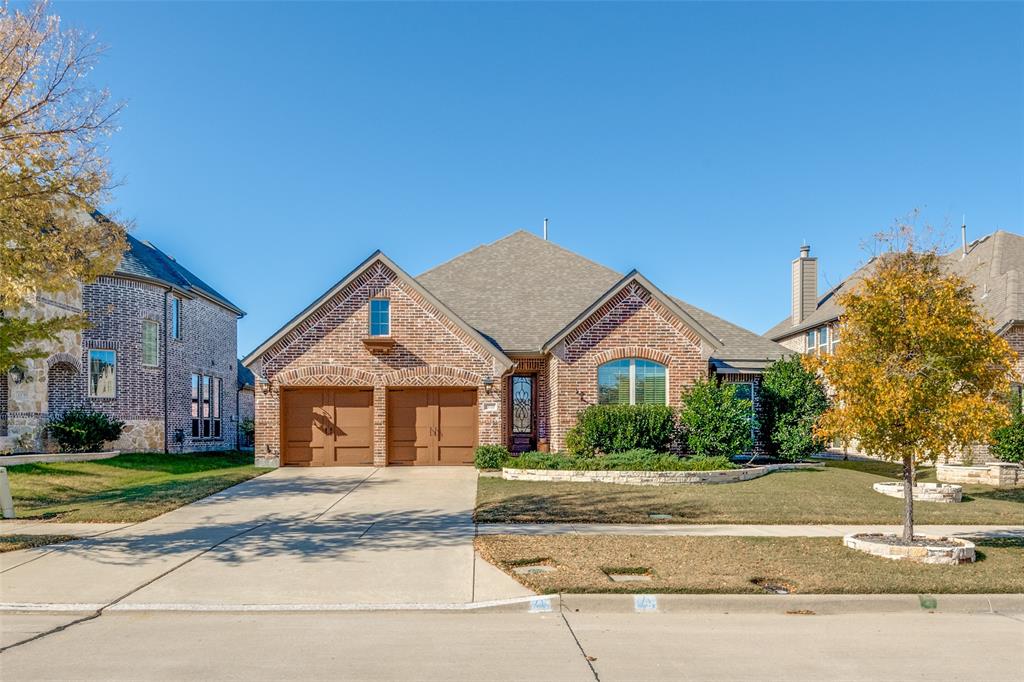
[282,388,477,466]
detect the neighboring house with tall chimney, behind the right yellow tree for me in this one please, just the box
[765,230,1024,460]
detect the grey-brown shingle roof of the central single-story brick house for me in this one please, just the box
[417,230,791,369]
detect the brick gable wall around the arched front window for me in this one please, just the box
[549,284,708,450]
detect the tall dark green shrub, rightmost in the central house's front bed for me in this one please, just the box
[761,356,828,460]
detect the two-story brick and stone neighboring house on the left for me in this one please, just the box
[0,236,245,452]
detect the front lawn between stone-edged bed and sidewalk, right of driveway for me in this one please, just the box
[476,462,1024,524]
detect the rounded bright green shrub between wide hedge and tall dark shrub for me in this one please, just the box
[679,379,753,457]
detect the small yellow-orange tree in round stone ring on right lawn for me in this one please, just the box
[806,226,1015,543]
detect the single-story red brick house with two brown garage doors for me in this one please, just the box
[243,231,787,466]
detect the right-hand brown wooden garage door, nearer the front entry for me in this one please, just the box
[387,388,477,465]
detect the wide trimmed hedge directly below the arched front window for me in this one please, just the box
[565,404,677,457]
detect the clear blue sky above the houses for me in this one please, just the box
[54,2,1024,354]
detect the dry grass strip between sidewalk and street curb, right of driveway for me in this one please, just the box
[476,535,1024,594]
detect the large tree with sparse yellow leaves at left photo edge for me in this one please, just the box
[0,0,127,373]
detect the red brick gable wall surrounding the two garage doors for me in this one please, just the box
[253,262,504,466]
